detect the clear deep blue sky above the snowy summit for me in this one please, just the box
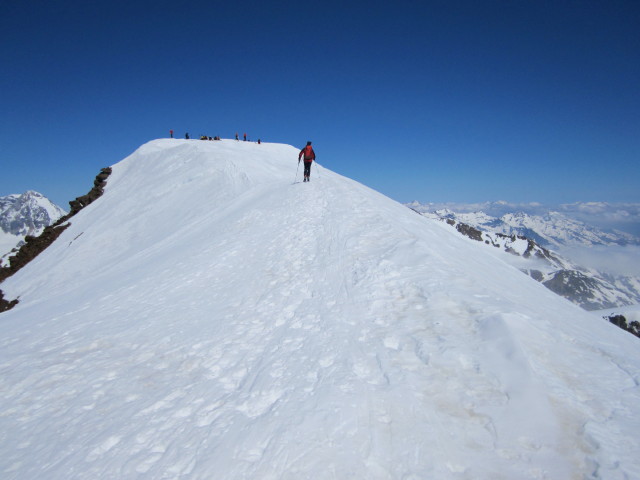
[0,0,640,207]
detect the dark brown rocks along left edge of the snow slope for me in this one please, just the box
[0,168,111,312]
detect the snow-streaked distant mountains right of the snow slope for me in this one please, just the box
[408,202,640,310]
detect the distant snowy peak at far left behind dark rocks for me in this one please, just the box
[0,190,67,265]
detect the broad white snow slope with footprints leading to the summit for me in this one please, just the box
[0,140,640,480]
